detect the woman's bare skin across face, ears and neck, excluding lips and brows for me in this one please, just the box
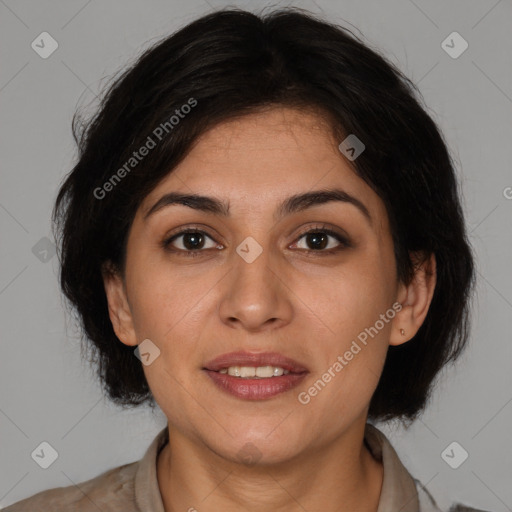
[104,107,435,512]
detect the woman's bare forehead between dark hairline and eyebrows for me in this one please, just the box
[138,107,386,228]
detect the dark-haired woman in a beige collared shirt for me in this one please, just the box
[6,9,492,512]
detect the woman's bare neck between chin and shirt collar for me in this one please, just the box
[157,424,383,512]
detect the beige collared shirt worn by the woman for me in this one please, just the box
[2,423,492,512]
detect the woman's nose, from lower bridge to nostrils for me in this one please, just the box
[219,246,293,332]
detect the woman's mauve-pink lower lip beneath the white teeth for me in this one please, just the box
[205,370,307,400]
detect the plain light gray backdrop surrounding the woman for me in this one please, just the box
[0,0,512,512]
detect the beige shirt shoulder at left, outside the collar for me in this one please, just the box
[1,462,138,512]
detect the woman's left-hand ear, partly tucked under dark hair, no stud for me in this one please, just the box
[102,262,137,346]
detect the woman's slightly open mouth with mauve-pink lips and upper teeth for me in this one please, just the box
[203,352,309,400]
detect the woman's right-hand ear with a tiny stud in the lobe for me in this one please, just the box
[389,253,437,345]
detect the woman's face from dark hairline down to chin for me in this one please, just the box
[108,108,410,463]
